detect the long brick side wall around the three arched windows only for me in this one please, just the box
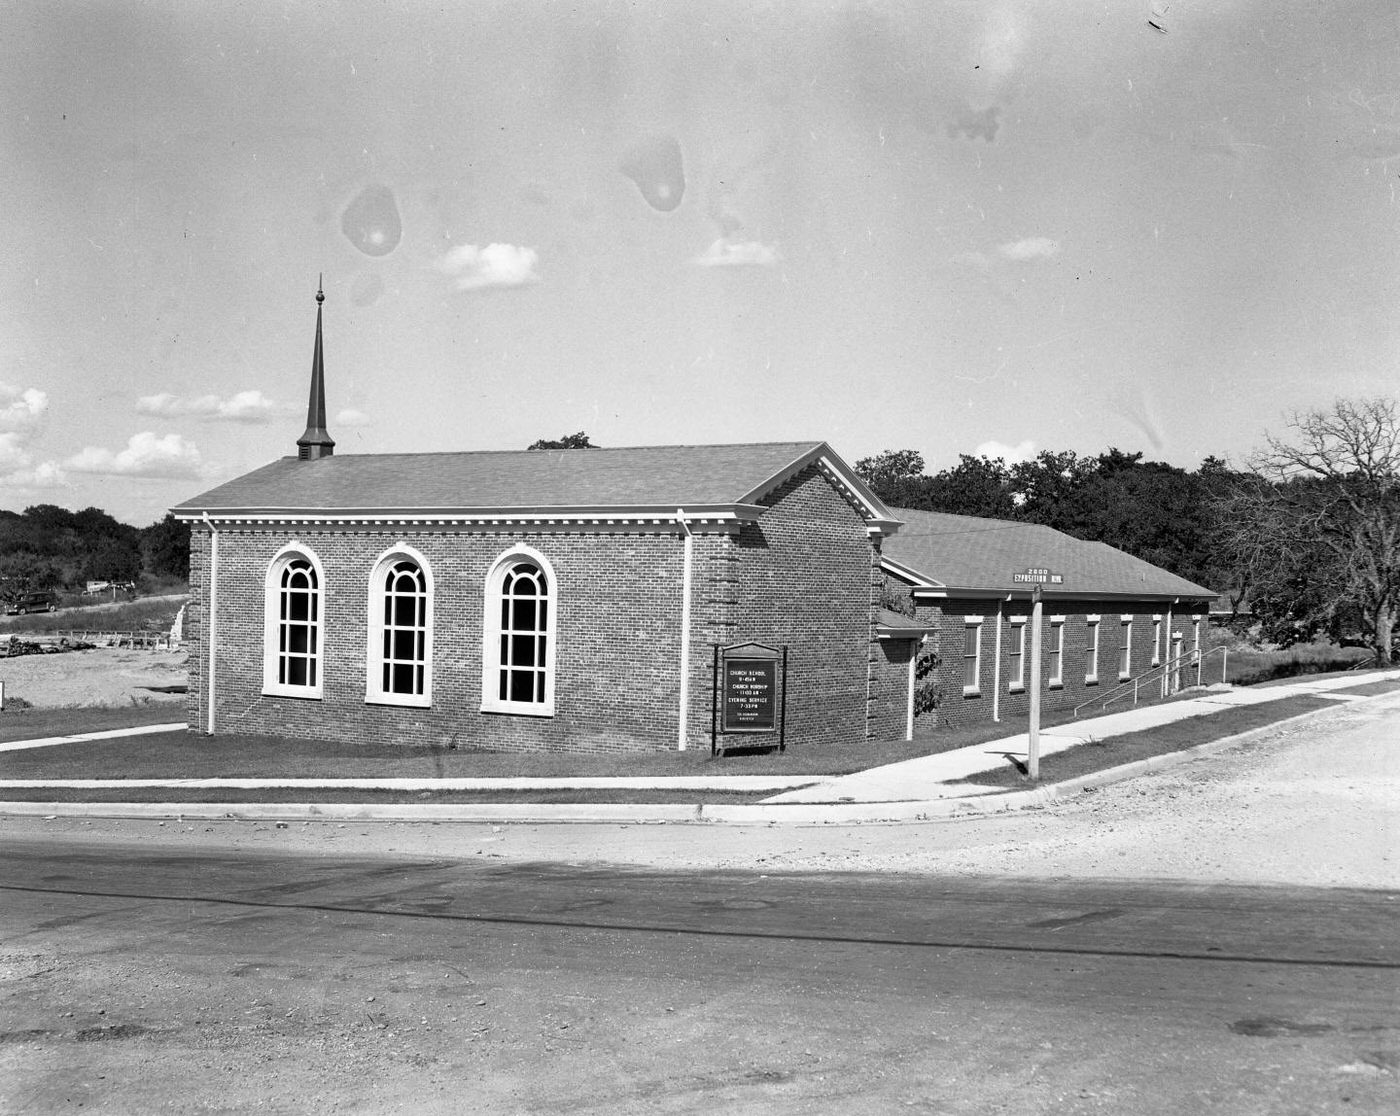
[190,528,680,752]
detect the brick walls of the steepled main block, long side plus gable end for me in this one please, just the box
[186,456,874,752]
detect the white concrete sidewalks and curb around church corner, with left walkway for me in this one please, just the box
[0,669,1400,825]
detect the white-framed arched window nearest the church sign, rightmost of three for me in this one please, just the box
[482,546,559,717]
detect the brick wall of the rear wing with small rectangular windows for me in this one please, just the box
[917,601,1204,727]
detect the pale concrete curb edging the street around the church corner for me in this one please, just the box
[0,683,1394,826]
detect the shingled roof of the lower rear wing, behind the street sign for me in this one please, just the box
[882,508,1215,599]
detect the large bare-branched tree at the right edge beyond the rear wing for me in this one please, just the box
[1215,399,1400,664]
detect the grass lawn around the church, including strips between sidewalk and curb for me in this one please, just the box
[0,676,1400,802]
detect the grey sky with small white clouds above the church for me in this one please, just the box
[0,0,1400,525]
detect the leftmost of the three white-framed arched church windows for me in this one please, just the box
[263,542,326,699]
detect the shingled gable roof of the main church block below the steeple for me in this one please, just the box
[172,441,897,529]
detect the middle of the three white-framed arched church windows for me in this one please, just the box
[364,543,434,709]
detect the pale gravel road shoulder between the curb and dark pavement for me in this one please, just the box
[10,695,1400,889]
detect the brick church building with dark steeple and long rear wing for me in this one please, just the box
[174,293,1214,752]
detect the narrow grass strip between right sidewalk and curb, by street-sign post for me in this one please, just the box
[958,682,1338,790]
